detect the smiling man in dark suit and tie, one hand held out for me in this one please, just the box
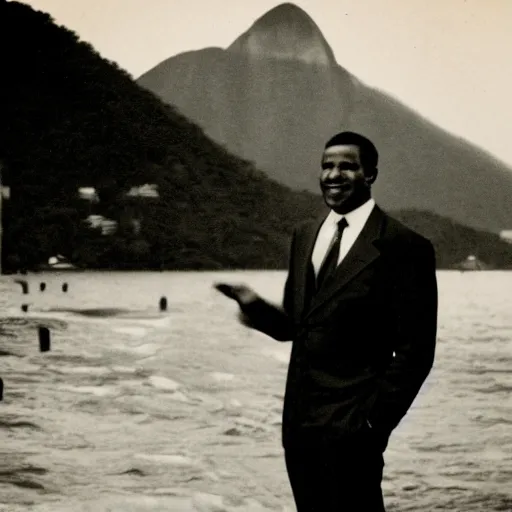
[216,132,437,512]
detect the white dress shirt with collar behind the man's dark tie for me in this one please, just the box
[311,198,375,276]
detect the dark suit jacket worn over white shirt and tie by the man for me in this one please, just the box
[242,206,437,447]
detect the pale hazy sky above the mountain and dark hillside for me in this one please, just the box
[20,0,512,165]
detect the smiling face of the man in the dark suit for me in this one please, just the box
[320,145,370,213]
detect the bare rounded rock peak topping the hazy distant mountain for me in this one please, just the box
[228,3,336,66]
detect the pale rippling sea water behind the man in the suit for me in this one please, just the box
[0,271,512,512]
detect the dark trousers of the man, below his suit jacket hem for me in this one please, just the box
[285,432,385,512]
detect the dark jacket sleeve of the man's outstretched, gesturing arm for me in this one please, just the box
[240,227,296,341]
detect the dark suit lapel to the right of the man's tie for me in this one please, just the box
[307,206,384,315]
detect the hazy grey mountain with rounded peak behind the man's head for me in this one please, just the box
[138,3,512,231]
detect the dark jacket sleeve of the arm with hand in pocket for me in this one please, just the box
[367,238,438,433]
